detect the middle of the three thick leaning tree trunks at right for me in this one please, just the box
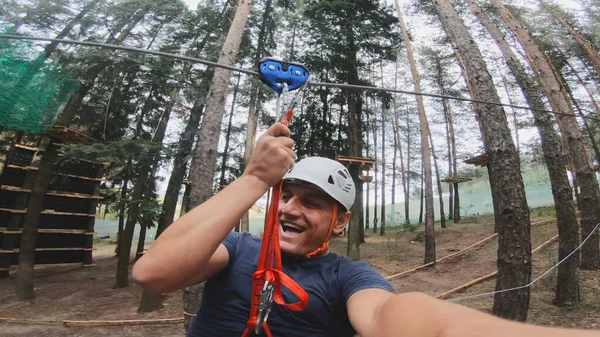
[467,0,579,305]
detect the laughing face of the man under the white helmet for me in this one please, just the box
[279,184,342,256]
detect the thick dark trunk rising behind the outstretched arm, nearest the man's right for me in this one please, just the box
[433,0,531,321]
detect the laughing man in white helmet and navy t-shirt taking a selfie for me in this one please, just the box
[133,123,600,337]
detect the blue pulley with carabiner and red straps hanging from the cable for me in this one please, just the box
[242,58,310,337]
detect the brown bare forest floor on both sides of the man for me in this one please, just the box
[0,205,600,337]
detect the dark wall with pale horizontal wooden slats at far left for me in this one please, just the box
[0,127,105,278]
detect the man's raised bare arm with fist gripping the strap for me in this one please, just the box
[132,123,295,293]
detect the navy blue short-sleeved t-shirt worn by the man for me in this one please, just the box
[188,232,394,337]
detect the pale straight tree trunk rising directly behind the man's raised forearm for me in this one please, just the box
[183,0,252,331]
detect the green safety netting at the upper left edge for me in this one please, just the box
[0,28,81,135]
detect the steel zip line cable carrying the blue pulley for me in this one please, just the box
[0,34,600,121]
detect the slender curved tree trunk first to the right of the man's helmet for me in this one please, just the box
[396,0,436,263]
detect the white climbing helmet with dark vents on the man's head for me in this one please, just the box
[283,157,356,210]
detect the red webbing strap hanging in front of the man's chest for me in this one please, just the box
[242,109,308,337]
